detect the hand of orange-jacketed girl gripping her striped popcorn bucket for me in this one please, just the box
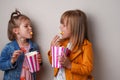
[58,52,71,69]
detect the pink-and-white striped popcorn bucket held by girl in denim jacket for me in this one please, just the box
[25,51,40,73]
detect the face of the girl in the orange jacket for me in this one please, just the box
[60,21,71,39]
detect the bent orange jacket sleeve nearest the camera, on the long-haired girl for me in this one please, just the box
[71,45,93,75]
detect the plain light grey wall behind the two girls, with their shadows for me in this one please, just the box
[0,0,120,80]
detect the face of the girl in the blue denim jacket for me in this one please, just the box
[18,20,32,39]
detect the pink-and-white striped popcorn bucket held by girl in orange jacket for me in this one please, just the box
[51,46,69,68]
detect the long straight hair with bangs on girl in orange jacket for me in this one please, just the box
[60,10,88,48]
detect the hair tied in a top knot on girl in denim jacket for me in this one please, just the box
[8,10,30,41]
